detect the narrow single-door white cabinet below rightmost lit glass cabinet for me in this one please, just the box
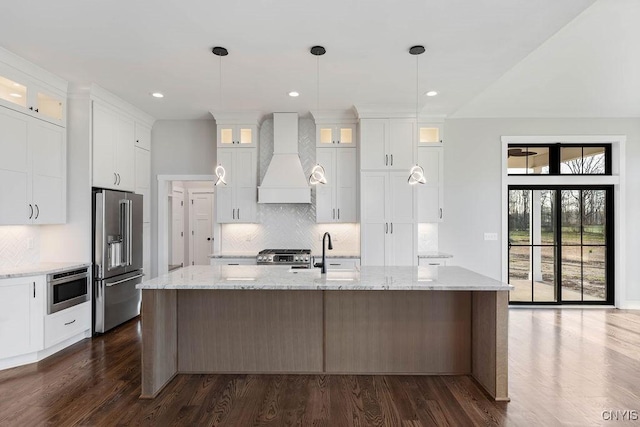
[415,147,444,222]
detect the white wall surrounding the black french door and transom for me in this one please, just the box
[438,119,640,308]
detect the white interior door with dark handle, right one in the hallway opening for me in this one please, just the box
[189,190,213,265]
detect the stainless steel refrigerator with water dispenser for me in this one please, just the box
[93,188,143,333]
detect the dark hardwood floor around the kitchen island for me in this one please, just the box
[0,308,640,426]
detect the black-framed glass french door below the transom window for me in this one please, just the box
[508,186,614,304]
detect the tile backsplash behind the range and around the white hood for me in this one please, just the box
[220,118,360,255]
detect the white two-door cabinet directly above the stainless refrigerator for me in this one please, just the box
[93,101,135,191]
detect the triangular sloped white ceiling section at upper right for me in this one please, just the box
[453,0,640,117]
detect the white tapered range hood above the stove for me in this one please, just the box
[258,113,311,203]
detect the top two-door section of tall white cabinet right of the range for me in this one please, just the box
[360,119,416,171]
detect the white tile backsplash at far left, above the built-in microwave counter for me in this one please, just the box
[0,225,40,267]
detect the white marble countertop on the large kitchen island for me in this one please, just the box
[136,265,513,291]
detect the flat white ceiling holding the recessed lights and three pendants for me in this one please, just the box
[0,0,624,119]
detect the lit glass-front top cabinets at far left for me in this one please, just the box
[0,62,66,127]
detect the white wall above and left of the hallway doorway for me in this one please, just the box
[151,119,216,276]
